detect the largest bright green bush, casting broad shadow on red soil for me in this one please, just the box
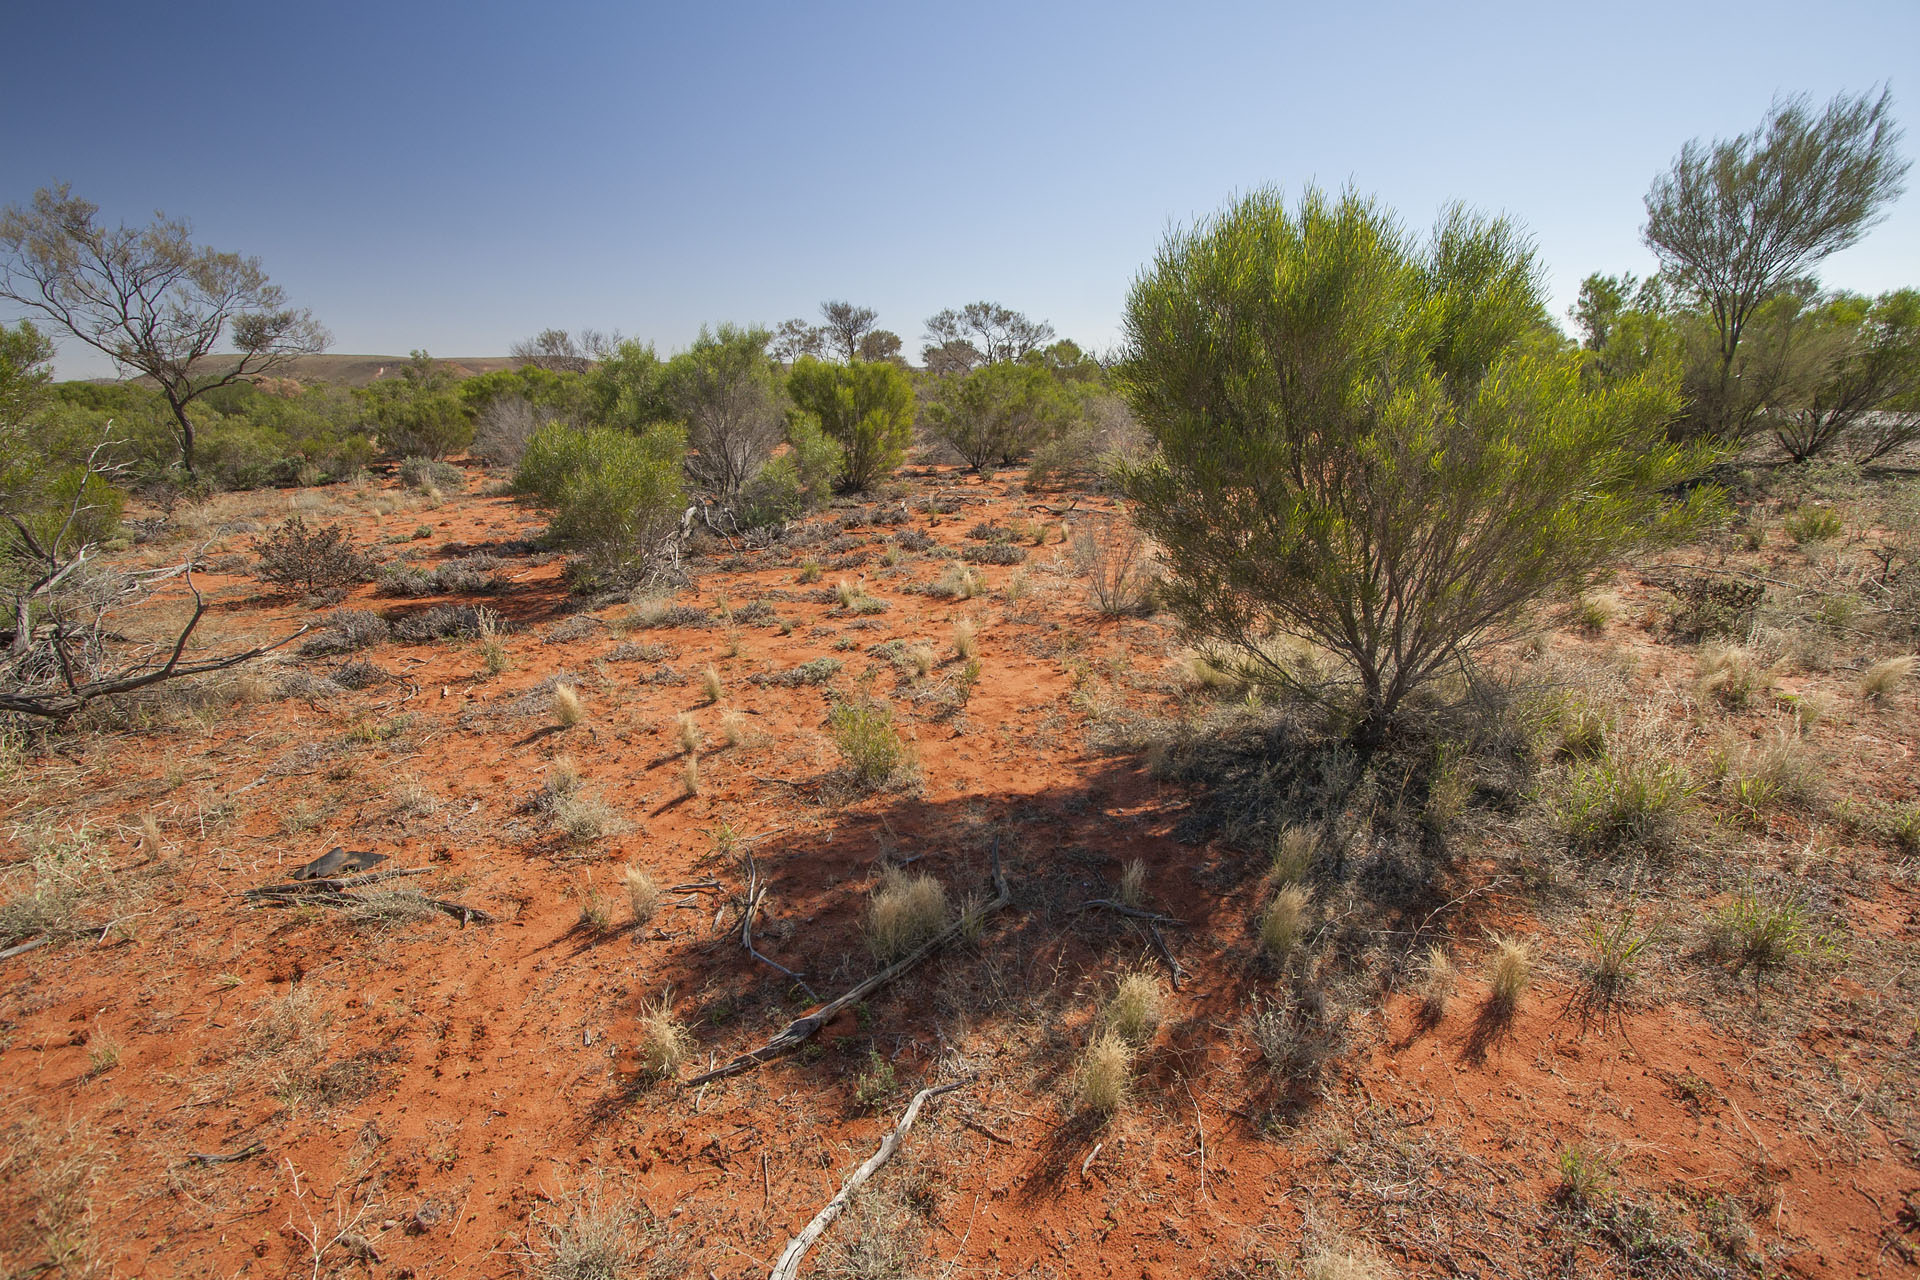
[1119,192,1716,745]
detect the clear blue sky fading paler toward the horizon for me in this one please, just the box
[0,0,1920,376]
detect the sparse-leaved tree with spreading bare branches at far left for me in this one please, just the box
[0,182,330,485]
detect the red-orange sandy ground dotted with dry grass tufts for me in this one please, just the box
[0,457,1920,1276]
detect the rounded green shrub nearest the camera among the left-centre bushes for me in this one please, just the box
[515,422,687,570]
